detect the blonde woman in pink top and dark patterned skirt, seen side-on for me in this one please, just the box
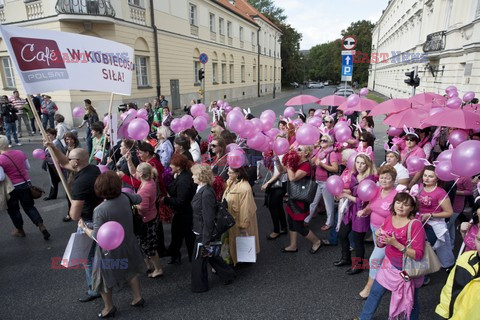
[135,162,163,278]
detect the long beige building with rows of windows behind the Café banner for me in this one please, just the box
[0,0,281,122]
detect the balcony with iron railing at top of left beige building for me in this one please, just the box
[55,0,115,22]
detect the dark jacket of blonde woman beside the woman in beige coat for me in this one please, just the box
[192,185,217,244]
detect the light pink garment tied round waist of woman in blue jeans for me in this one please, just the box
[375,257,423,320]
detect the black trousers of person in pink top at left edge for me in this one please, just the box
[7,183,43,229]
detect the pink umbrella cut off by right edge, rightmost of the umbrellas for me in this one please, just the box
[424,108,480,129]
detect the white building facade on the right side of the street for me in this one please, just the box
[368,0,480,98]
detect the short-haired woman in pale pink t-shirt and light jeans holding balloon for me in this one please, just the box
[357,164,397,300]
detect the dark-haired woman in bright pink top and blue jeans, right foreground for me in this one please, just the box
[359,192,425,320]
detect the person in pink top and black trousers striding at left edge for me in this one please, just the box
[0,136,50,240]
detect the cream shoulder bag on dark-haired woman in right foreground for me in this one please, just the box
[403,220,442,278]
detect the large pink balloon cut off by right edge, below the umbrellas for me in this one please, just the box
[452,140,480,177]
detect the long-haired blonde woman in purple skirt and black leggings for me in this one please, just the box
[333,153,375,275]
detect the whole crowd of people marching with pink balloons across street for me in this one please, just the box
[0,96,480,320]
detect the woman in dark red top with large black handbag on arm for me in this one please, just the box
[282,145,322,254]
